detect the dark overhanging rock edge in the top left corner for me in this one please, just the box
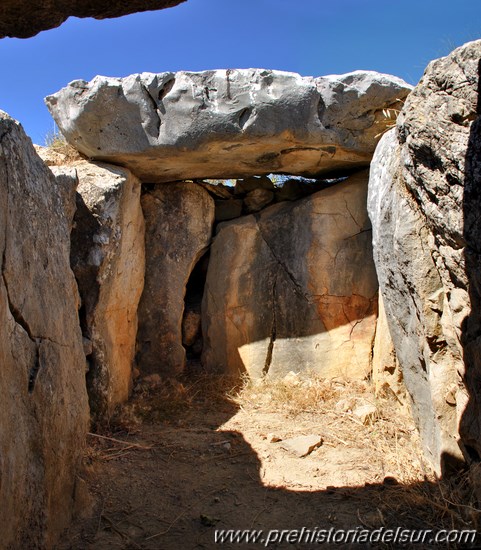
[0,0,185,38]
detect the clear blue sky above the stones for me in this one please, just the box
[0,0,481,144]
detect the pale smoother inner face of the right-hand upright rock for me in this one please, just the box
[369,130,462,470]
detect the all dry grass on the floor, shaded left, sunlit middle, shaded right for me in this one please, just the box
[102,373,481,548]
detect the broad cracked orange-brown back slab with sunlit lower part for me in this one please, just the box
[202,172,378,378]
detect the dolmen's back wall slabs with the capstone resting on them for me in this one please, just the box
[42,69,410,388]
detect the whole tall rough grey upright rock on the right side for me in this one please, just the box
[369,41,481,469]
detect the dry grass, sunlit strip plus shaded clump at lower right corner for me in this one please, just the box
[231,373,481,548]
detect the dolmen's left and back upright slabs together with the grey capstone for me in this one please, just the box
[0,64,424,547]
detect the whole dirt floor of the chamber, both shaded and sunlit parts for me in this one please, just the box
[59,376,479,550]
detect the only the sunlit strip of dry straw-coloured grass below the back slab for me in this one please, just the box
[231,373,426,483]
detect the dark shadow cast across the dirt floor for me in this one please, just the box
[59,380,475,550]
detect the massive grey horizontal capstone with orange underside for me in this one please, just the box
[46,69,411,182]
